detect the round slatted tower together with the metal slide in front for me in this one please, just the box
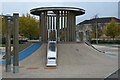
[30,7,85,66]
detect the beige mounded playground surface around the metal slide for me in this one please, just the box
[2,43,118,78]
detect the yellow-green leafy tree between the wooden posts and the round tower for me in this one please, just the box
[19,14,39,39]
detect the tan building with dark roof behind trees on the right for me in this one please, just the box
[78,17,120,39]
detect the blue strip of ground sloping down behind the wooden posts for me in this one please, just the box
[0,43,42,65]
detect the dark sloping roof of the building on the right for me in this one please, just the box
[78,17,120,25]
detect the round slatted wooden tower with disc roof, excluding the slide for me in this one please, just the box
[30,7,85,42]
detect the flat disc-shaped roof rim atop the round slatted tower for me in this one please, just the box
[30,7,85,15]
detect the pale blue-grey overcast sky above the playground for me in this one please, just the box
[2,2,118,24]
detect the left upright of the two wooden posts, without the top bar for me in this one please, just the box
[5,17,11,72]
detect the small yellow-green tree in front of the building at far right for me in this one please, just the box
[105,19,119,40]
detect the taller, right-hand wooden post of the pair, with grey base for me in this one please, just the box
[13,13,19,73]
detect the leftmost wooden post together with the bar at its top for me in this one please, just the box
[0,15,13,72]
